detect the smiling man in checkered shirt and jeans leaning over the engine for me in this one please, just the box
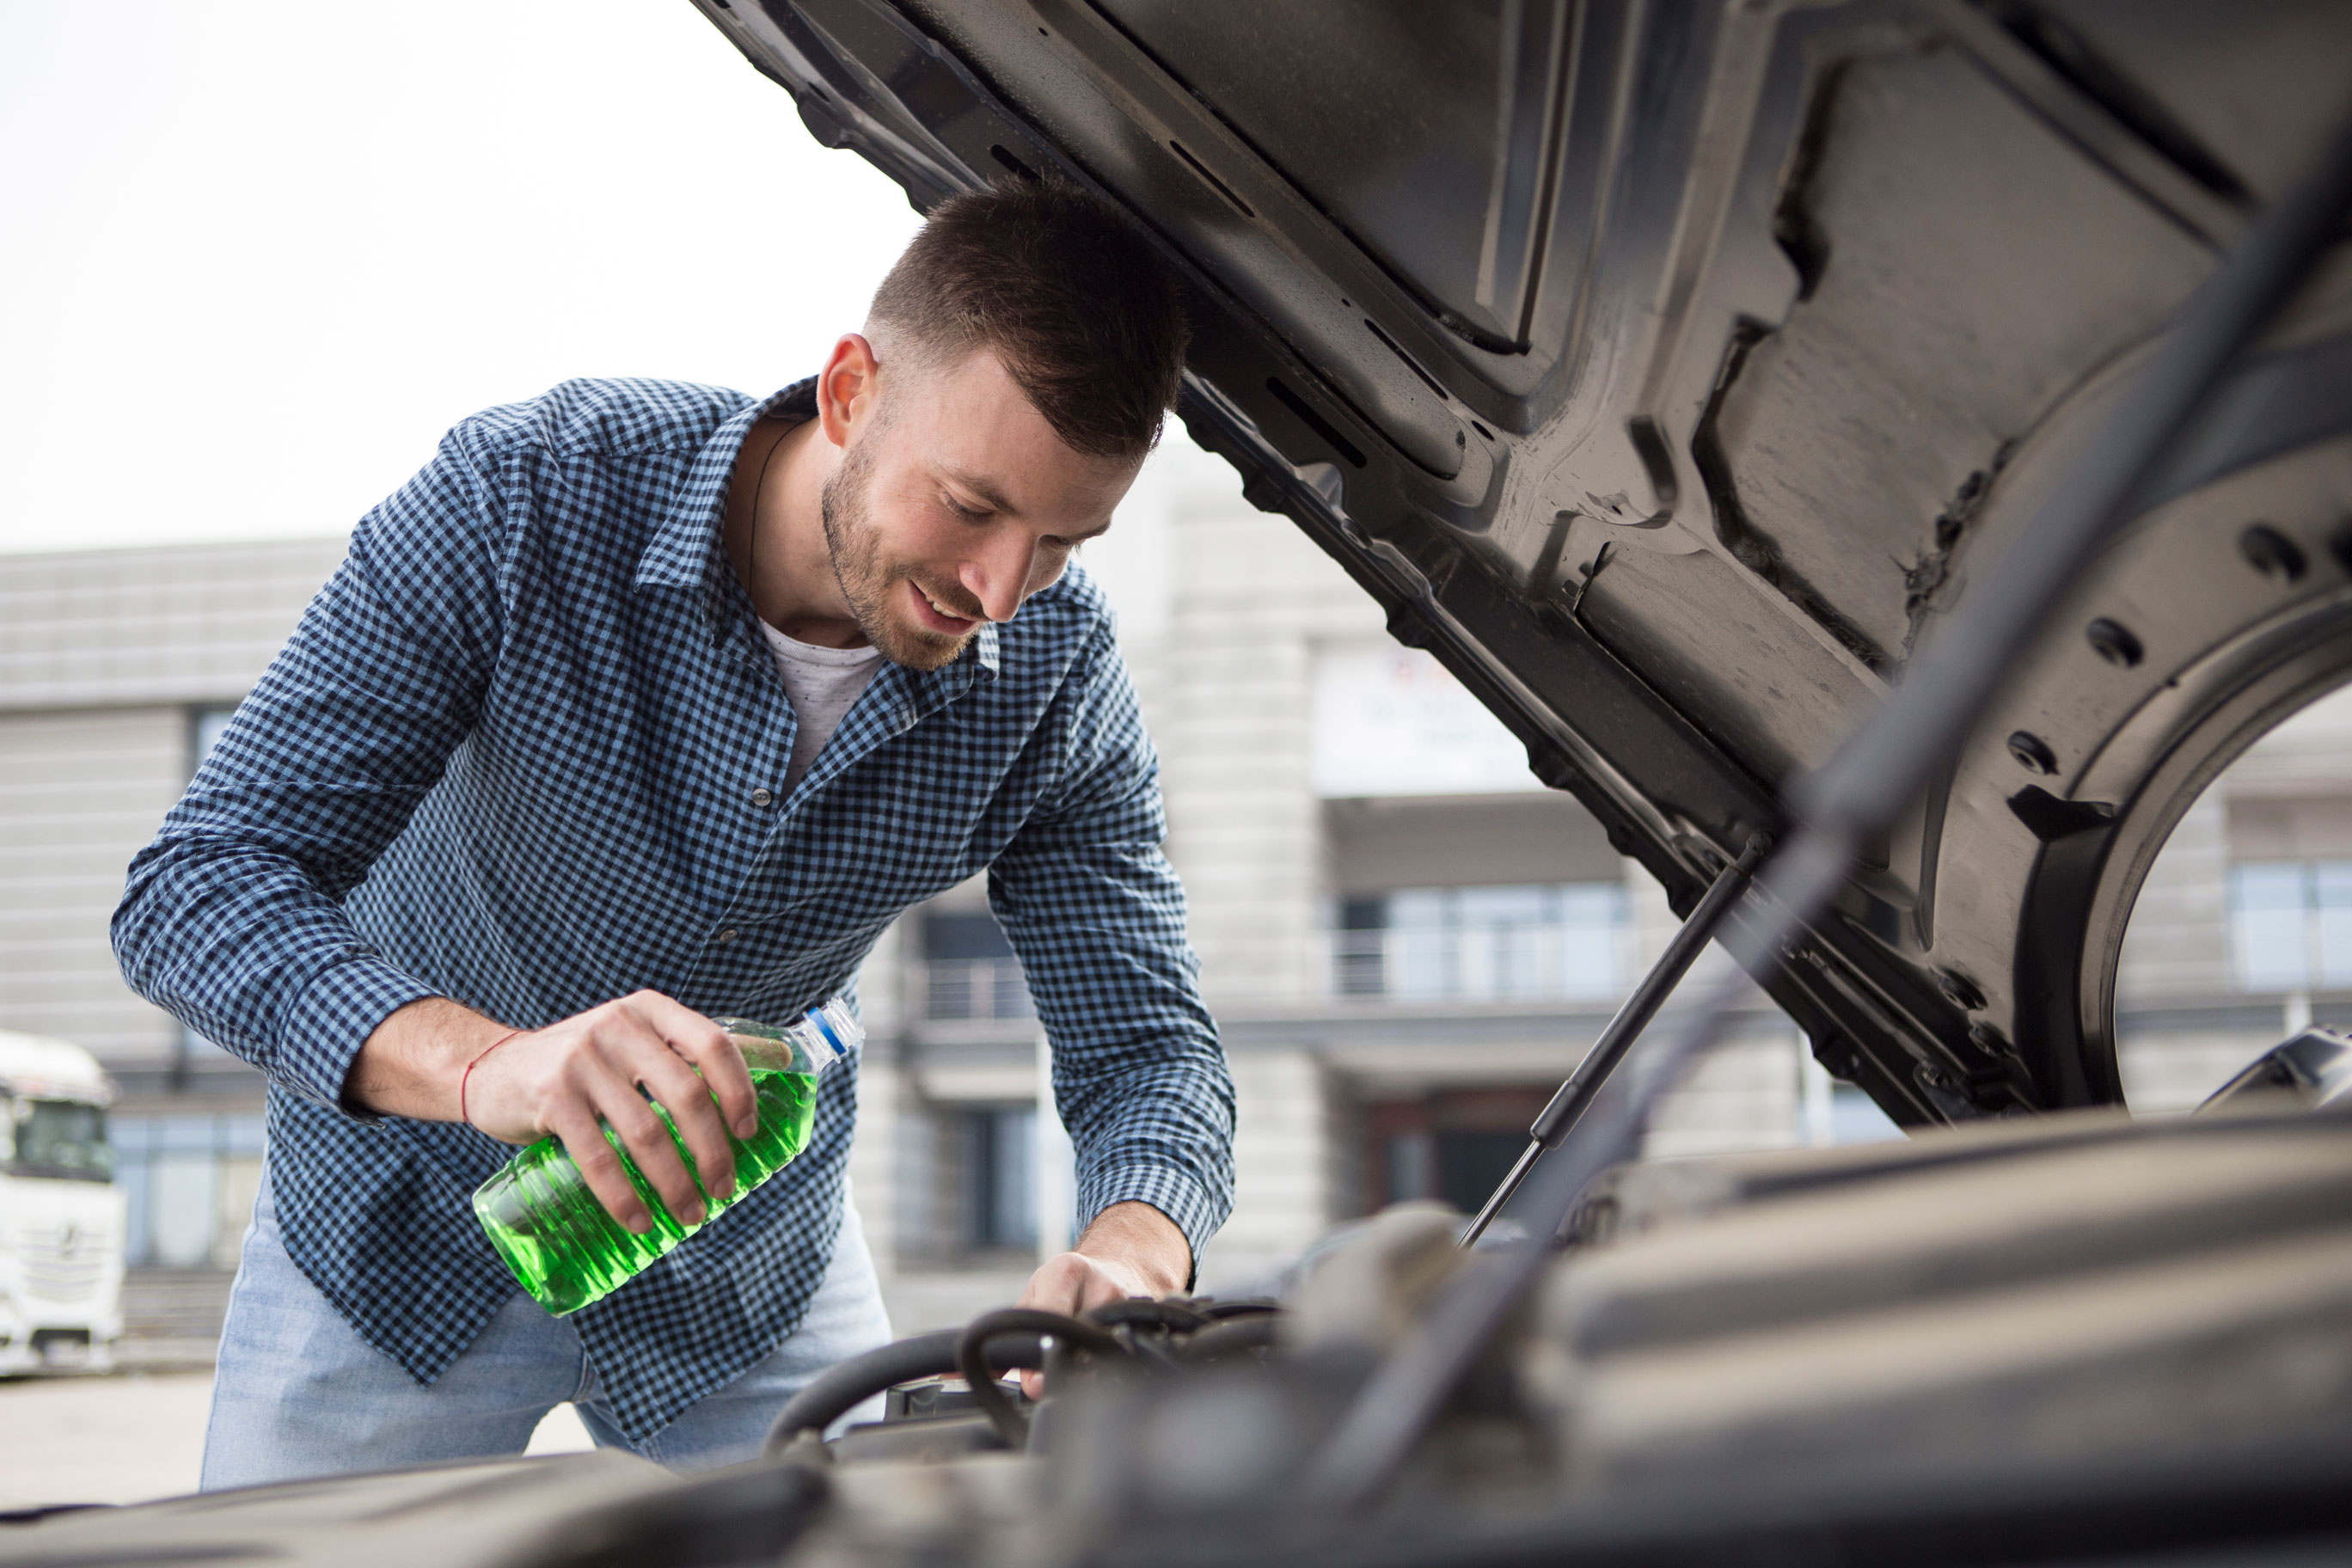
[115,183,1233,1488]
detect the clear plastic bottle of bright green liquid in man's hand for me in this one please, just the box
[473,996,866,1316]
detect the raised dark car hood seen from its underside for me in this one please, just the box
[696,0,2352,1126]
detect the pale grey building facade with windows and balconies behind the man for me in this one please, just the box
[0,438,2324,1331]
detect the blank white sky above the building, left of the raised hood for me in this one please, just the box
[0,0,917,550]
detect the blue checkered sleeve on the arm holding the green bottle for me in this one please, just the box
[113,420,504,1114]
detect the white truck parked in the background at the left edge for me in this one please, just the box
[0,1030,125,1375]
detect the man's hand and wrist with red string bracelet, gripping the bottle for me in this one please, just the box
[343,992,760,1234]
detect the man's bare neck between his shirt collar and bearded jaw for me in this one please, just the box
[726,419,866,649]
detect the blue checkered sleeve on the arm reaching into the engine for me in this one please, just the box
[990,623,1234,1262]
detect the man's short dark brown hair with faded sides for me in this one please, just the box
[868,179,1190,458]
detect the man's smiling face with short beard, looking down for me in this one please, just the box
[824,350,1141,670]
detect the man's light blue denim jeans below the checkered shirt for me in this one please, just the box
[202,1175,891,1492]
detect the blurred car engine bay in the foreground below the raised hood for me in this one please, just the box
[0,1048,2352,1568]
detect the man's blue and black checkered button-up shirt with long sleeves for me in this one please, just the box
[113,381,1233,1439]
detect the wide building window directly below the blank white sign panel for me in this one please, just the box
[1332,881,1630,1001]
